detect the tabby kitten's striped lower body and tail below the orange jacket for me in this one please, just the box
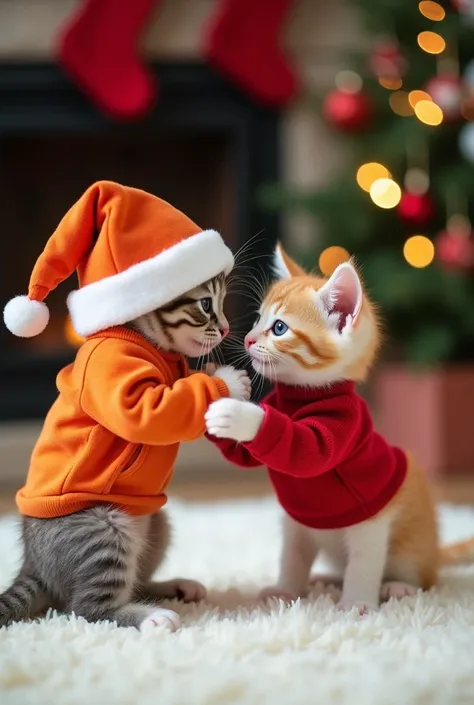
[0,506,205,628]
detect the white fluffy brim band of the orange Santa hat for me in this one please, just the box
[67,230,234,337]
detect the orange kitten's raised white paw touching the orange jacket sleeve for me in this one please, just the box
[205,399,265,443]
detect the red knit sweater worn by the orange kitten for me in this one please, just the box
[212,382,407,529]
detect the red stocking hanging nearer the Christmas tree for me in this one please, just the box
[204,0,298,106]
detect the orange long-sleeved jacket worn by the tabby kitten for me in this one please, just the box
[17,327,228,518]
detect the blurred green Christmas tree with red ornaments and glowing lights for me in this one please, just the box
[265,0,474,366]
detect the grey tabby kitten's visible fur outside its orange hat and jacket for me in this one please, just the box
[0,274,244,630]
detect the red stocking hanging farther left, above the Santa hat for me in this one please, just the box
[58,0,159,119]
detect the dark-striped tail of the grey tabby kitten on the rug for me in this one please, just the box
[0,574,46,627]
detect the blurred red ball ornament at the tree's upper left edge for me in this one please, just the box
[323,90,372,132]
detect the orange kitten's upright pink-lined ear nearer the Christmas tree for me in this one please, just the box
[317,262,362,333]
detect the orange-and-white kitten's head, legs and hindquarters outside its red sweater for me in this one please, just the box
[250,247,474,612]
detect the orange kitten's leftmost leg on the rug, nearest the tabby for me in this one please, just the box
[260,516,318,602]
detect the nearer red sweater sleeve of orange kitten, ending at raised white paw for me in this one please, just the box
[243,403,361,478]
